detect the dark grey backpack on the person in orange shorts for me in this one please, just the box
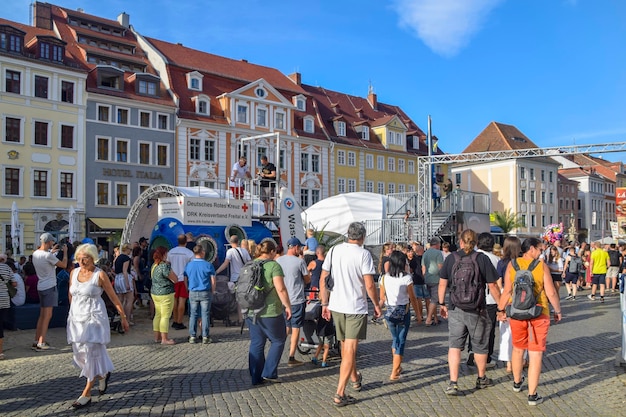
[506,259,543,320]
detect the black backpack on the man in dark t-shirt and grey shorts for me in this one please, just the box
[450,252,485,311]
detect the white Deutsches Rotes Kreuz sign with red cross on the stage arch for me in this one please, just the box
[159,196,252,227]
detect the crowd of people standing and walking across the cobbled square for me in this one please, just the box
[0,226,626,408]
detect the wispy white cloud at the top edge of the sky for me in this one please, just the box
[394,0,504,57]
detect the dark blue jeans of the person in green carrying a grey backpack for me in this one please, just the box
[246,314,287,385]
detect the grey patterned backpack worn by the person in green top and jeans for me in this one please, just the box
[235,260,274,320]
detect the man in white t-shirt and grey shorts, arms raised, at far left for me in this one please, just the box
[32,233,67,352]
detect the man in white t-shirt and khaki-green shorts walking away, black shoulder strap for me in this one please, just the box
[320,222,381,406]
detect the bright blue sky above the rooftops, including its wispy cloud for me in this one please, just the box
[6,0,626,160]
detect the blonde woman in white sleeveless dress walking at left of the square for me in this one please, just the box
[67,244,128,409]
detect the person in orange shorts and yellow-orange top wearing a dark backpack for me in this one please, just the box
[498,237,561,405]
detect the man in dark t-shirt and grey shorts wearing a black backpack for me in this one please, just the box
[438,229,500,395]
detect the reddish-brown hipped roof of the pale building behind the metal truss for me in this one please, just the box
[463,122,538,153]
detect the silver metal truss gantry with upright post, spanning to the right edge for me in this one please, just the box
[415,142,626,241]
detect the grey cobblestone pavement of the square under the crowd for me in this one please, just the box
[0,291,626,417]
